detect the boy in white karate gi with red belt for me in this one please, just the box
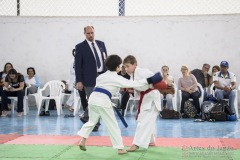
[123,55,161,152]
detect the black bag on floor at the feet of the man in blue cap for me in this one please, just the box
[210,100,229,121]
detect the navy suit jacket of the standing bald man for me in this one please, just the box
[75,40,107,87]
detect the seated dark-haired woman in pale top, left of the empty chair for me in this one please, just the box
[24,67,41,94]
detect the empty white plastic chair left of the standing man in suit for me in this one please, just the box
[37,80,65,115]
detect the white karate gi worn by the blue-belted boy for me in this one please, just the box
[78,71,151,149]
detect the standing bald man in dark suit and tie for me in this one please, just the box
[75,26,107,131]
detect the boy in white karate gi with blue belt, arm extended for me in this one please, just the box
[78,55,162,154]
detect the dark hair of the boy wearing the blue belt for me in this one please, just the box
[105,54,122,71]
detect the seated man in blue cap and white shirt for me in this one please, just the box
[213,61,237,113]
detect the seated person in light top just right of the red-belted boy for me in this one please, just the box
[159,66,174,109]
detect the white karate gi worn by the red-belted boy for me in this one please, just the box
[130,67,161,148]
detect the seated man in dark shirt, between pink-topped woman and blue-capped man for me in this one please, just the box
[191,63,211,101]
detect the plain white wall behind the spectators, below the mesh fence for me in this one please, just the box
[0,15,240,87]
